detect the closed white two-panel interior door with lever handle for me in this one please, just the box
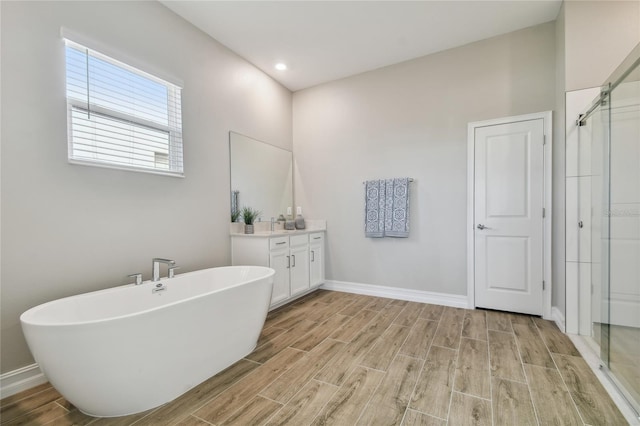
[473,119,544,315]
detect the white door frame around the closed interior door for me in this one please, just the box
[467,111,553,319]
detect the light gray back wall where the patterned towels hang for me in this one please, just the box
[293,22,564,295]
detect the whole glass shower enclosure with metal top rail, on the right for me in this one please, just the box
[579,45,640,413]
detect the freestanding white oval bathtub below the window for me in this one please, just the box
[20,266,274,417]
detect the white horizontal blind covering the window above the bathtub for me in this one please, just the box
[65,40,184,176]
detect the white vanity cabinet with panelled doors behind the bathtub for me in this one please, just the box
[231,232,324,307]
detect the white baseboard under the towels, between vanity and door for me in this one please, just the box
[320,280,471,309]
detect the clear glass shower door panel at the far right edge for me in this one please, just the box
[601,62,640,411]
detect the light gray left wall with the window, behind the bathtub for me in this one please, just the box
[0,2,292,372]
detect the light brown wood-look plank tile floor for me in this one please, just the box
[0,291,627,426]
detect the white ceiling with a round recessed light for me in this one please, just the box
[160,0,562,91]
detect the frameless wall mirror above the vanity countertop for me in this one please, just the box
[229,132,293,221]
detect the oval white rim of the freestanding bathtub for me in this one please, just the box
[20,265,276,327]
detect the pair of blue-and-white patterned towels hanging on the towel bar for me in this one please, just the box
[364,178,409,238]
